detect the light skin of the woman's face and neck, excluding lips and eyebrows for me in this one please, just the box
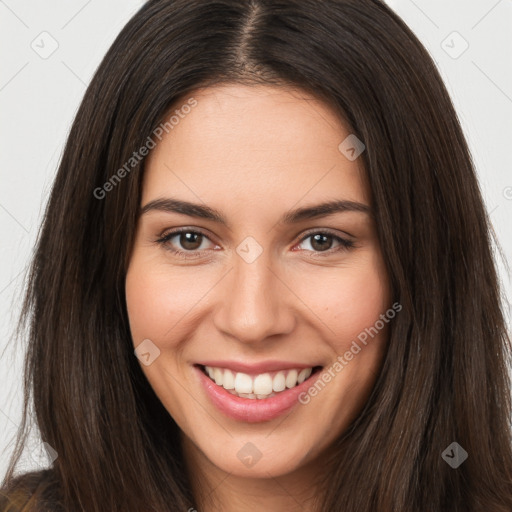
[126,84,390,512]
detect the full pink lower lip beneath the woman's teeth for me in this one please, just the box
[194,366,320,423]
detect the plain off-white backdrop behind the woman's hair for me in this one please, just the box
[0,0,512,476]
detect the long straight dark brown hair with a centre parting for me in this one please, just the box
[3,0,512,512]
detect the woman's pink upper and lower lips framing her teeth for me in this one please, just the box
[194,361,320,423]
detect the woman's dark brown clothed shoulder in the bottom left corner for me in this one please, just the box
[0,469,61,512]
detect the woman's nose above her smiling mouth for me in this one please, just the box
[214,247,295,344]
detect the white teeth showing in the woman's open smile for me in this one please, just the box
[197,365,322,400]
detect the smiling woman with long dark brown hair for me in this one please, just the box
[3,0,512,512]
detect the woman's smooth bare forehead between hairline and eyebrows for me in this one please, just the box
[143,85,369,207]
